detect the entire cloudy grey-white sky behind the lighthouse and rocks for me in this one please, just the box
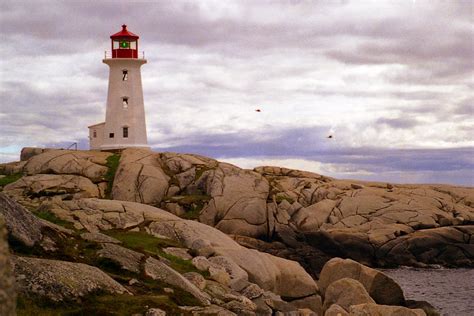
[0,0,474,185]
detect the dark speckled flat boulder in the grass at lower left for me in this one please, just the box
[12,256,129,302]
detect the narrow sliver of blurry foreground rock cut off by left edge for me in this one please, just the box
[0,215,16,316]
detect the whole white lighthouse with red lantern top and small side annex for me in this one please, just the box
[89,24,149,150]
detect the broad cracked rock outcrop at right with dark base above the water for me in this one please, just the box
[255,167,474,266]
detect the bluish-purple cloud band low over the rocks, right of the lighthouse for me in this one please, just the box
[153,126,474,172]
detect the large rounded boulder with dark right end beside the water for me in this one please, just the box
[318,258,405,305]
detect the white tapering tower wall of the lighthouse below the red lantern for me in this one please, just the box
[100,58,148,150]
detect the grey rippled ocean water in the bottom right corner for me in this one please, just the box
[382,267,474,316]
